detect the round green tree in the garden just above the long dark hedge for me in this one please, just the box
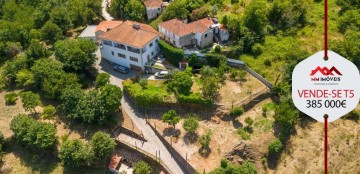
[168,72,193,95]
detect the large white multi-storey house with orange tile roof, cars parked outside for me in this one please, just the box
[100,21,160,70]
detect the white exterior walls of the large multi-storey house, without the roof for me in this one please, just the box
[100,37,160,70]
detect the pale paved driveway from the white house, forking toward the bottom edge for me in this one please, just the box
[96,50,185,174]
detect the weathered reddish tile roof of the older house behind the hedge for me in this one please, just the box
[159,18,214,36]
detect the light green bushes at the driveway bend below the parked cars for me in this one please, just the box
[123,80,167,108]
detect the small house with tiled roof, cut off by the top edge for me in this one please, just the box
[144,0,166,20]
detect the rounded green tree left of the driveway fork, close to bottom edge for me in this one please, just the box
[90,132,116,161]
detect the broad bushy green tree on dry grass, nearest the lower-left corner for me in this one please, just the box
[10,115,56,150]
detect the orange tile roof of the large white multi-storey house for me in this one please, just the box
[100,21,159,48]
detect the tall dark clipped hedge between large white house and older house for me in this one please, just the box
[159,40,184,67]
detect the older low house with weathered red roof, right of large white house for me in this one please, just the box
[159,17,229,48]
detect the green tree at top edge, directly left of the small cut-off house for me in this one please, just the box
[124,0,145,22]
